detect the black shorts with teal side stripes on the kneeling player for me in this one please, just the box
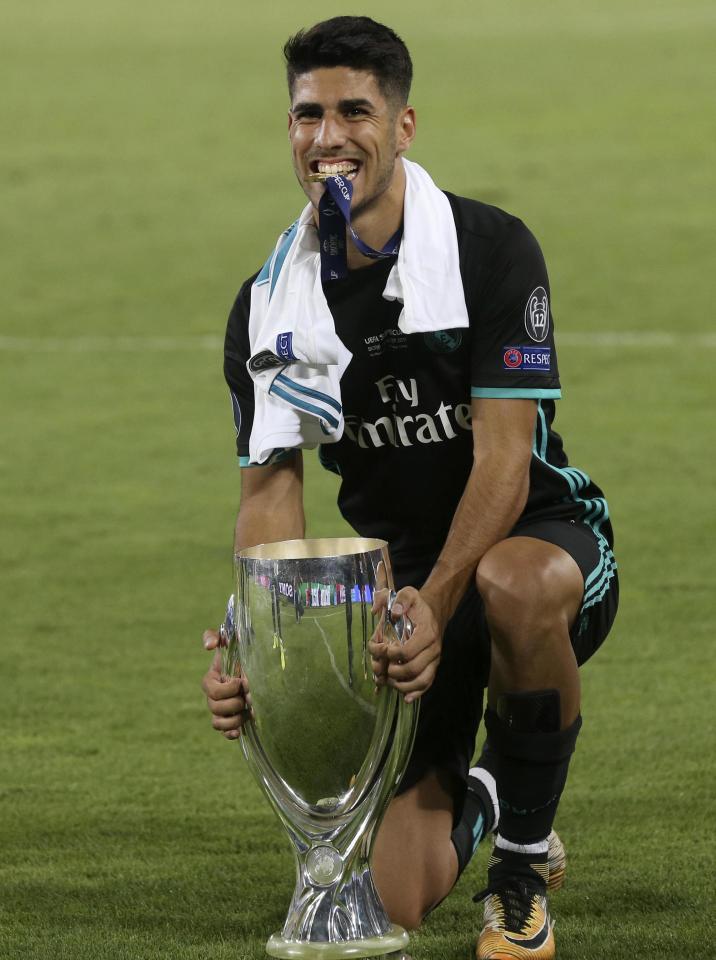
[398,519,619,817]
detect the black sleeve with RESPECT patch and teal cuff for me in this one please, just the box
[470,219,561,400]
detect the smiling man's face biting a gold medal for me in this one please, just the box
[288,67,415,216]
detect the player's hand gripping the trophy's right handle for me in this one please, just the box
[368,587,443,703]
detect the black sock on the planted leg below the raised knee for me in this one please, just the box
[480,707,582,845]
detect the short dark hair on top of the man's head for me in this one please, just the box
[283,17,413,106]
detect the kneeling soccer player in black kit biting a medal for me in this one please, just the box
[204,17,618,960]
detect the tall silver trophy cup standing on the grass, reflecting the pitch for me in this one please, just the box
[221,537,418,960]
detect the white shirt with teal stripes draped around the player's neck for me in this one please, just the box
[247,160,469,464]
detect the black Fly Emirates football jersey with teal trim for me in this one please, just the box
[224,194,612,586]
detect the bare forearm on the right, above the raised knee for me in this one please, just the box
[420,451,529,624]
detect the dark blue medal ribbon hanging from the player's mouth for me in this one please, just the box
[318,176,403,283]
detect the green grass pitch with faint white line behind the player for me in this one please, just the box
[0,0,716,960]
